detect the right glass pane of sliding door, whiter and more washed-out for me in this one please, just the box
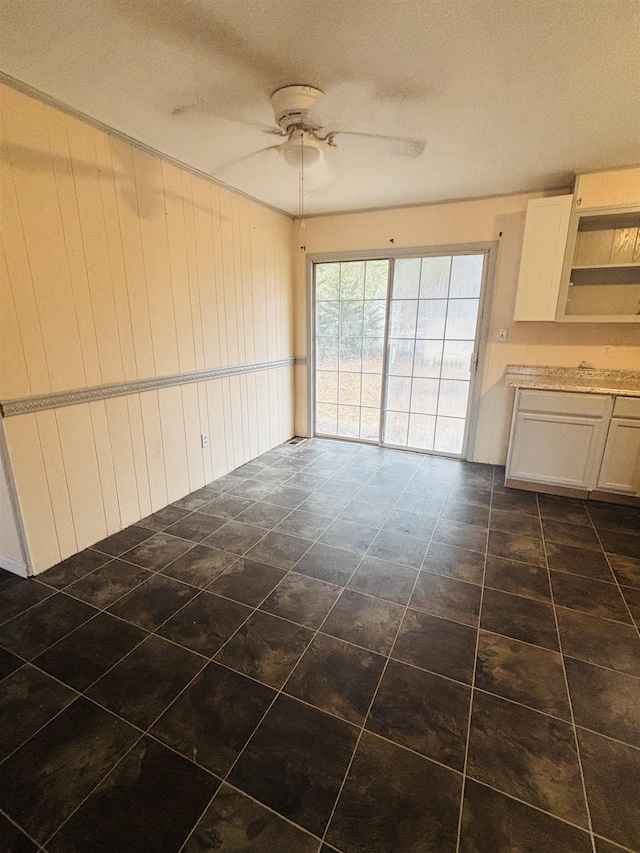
[383,254,484,455]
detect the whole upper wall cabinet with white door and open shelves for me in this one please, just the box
[514,168,640,323]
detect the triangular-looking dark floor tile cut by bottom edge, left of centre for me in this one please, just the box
[184,785,318,853]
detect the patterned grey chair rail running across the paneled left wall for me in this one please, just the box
[0,358,295,418]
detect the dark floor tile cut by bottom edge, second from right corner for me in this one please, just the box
[459,779,592,853]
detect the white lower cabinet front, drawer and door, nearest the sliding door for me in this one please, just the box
[506,389,613,493]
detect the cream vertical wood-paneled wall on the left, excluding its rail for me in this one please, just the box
[0,85,293,571]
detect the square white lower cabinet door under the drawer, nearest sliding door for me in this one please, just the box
[507,412,606,490]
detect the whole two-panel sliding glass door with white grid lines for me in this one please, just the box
[314,252,486,456]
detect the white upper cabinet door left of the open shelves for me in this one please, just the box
[513,195,573,320]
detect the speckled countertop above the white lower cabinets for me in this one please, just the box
[506,364,640,397]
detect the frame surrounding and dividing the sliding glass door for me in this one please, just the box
[306,241,499,460]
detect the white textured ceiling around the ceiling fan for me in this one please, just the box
[0,0,640,213]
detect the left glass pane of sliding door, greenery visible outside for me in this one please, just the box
[315,260,390,441]
